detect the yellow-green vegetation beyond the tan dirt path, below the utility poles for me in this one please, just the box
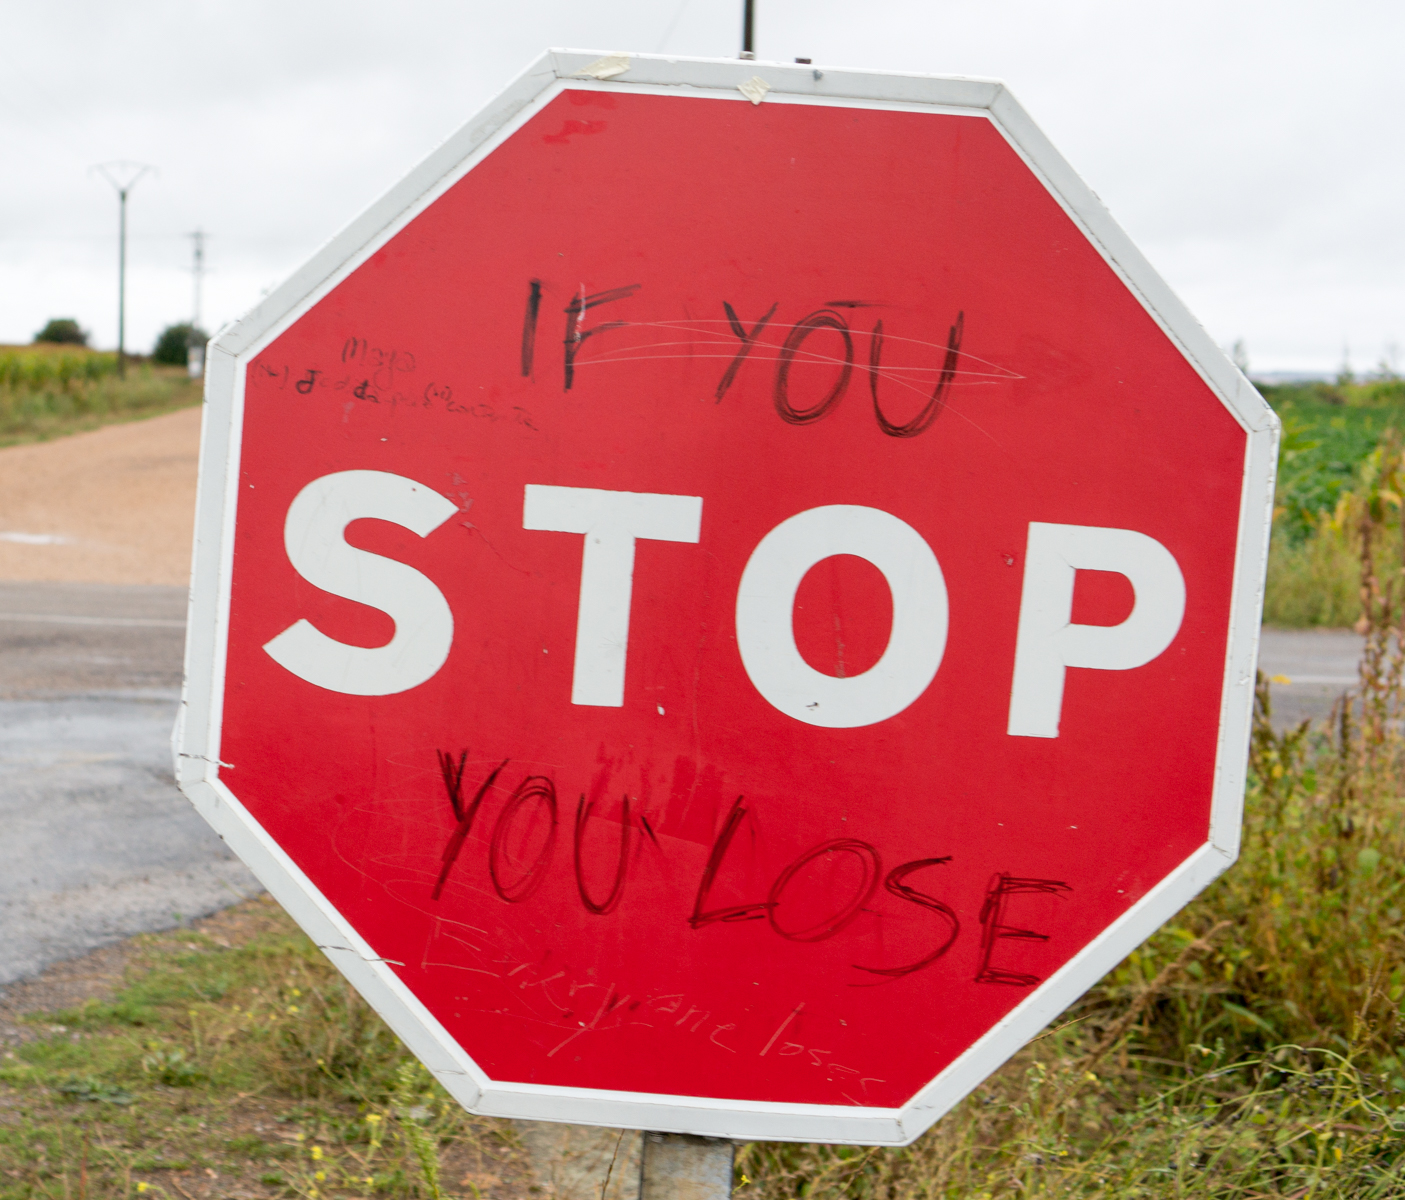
[0,347,201,445]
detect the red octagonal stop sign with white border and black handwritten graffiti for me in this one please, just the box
[177,52,1277,1144]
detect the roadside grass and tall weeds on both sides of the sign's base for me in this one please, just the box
[8,474,1405,1200]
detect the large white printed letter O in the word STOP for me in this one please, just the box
[736,504,947,729]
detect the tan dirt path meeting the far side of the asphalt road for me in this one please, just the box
[0,407,201,587]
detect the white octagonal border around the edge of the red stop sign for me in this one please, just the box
[173,51,1279,1145]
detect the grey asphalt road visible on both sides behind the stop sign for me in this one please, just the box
[0,583,1360,985]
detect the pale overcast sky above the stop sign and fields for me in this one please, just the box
[0,0,1405,372]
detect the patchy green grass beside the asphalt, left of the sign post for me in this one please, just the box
[0,899,527,1200]
